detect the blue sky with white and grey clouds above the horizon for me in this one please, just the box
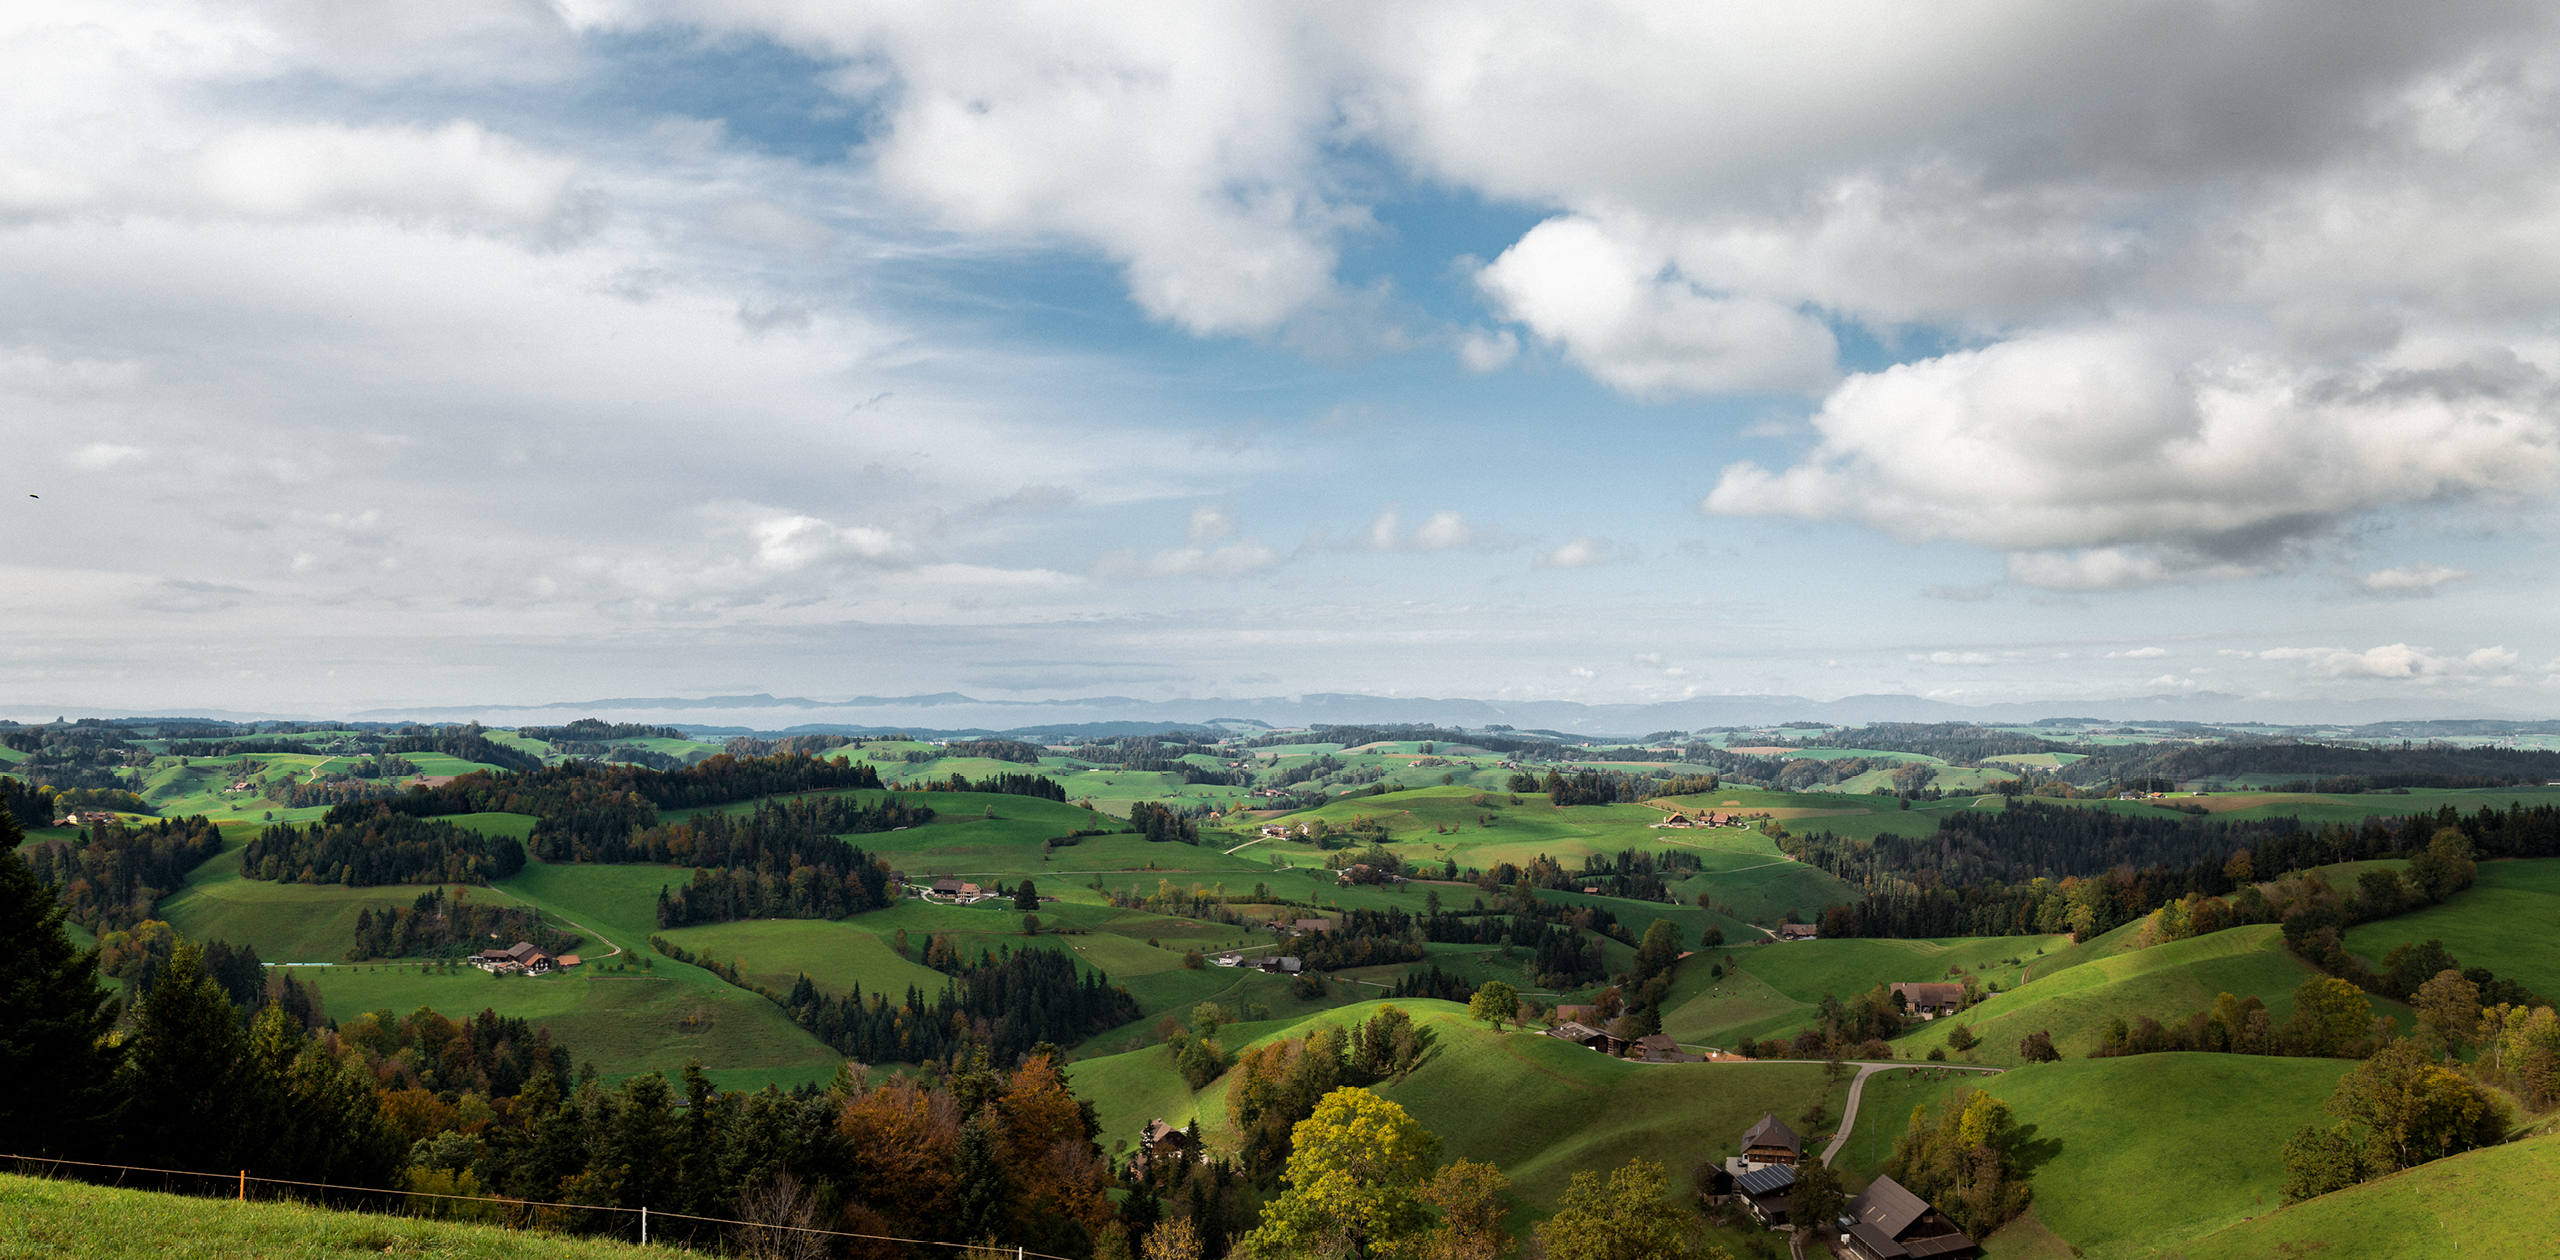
[0,0,2560,715]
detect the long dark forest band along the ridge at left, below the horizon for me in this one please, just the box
[355,753,881,860]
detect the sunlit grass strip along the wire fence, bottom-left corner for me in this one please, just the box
[0,1173,648,1260]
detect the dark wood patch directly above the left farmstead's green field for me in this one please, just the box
[241,802,525,889]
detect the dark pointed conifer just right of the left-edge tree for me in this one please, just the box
[120,940,254,1173]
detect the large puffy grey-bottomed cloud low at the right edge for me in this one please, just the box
[1702,330,2560,589]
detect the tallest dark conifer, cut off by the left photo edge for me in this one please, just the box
[0,829,120,1158]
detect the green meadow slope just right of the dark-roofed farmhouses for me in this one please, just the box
[1838,1053,2355,1260]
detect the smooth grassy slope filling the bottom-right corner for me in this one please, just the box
[2163,1135,2560,1260]
